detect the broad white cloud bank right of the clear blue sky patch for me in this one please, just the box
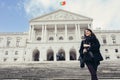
[24,0,120,29]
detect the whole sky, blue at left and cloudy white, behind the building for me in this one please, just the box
[0,0,120,32]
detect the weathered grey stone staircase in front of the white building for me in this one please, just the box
[0,60,120,80]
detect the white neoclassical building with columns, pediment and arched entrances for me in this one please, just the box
[0,10,120,62]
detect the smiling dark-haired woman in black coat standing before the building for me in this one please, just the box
[79,29,103,80]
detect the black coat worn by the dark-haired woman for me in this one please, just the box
[79,36,103,62]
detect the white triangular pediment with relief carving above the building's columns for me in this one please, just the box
[31,9,92,22]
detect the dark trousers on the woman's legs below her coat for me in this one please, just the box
[86,62,98,80]
